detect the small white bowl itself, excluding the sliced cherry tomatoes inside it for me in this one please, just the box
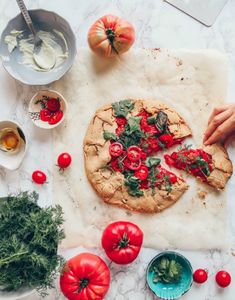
[28,90,67,129]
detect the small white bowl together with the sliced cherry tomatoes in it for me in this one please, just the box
[28,90,67,129]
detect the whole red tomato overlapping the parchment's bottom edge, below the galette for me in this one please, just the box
[102,221,143,264]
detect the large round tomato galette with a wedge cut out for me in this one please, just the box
[84,99,191,213]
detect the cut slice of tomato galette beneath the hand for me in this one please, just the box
[164,144,233,190]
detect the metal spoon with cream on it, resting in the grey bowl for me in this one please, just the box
[16,0,56,69]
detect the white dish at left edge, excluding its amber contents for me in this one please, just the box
[0,120,27,171]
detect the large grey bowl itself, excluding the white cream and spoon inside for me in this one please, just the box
[0,9,76,85]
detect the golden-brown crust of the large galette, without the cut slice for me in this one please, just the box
[84,99,191,213]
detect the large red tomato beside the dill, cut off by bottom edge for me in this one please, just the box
[60,253,110,300]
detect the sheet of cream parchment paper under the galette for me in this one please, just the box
[53,49,228,250]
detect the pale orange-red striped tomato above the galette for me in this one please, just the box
[88,15,135,57]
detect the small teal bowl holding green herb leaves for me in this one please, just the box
[147,251,193,300]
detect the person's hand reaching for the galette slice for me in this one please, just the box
[203,104,235,145]
